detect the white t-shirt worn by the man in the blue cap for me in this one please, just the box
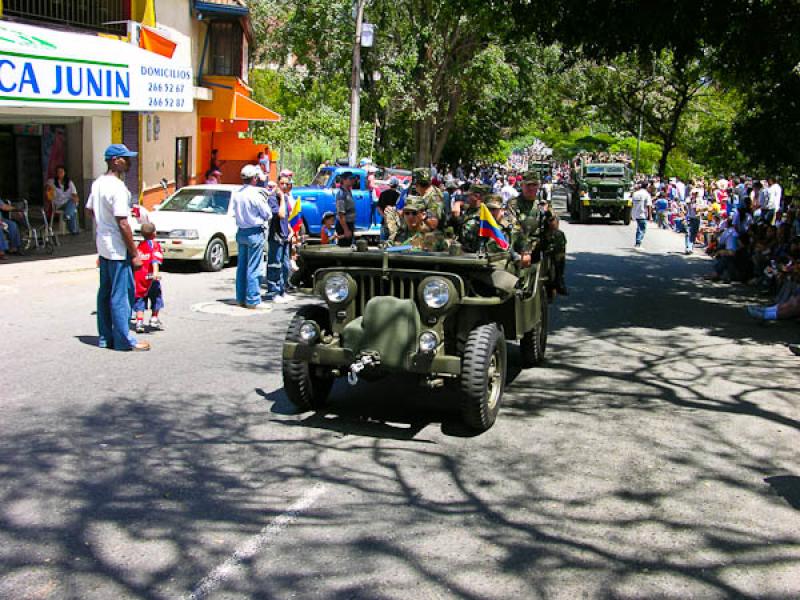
[86,175,131,260]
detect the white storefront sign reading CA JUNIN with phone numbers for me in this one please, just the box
[0,21,193,112]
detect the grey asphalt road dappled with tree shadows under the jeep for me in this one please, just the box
[0,193,800,600]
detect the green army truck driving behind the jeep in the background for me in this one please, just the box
[567,163,633,225]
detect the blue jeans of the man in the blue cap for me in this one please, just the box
[97,256,136,350]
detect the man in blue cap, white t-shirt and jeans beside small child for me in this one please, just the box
[86,144,150,352]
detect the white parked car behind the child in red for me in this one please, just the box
[135,184,266,271]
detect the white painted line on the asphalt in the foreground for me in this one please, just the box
[186,483,325,600]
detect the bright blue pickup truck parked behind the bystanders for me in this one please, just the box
[292,167,381,237]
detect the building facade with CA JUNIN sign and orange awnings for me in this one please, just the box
[0,0,280,216]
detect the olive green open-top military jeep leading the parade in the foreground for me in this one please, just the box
[283,246,549,431]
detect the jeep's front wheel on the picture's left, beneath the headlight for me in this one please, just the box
[282,306,334,410]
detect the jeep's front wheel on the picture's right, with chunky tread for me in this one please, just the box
[460,323,507,431]
